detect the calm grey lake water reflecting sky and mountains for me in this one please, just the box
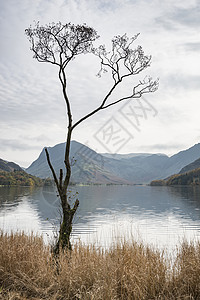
[0,186,200,247]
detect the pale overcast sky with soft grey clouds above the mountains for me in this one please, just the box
[0,0,200,167]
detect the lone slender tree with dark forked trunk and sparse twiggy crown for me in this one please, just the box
[25,22,158,252]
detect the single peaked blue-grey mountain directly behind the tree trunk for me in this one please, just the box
[26,141,130,184]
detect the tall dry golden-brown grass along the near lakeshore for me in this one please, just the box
[0,233,200,300]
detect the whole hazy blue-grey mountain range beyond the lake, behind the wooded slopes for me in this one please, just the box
[26,141,200,184]
